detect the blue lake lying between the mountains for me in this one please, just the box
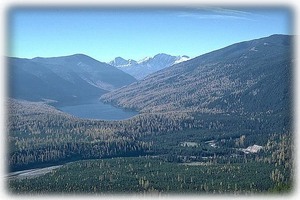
[58,101,138,121]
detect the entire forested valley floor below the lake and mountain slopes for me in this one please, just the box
[7,101,294,194]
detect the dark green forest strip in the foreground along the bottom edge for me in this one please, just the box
[9,156,288,194]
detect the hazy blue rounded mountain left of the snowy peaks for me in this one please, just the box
[8,54,136,103]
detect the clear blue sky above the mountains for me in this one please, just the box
[7,7,293,62]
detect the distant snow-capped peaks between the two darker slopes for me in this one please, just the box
[109,53,189,80]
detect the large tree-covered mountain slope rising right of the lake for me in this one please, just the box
[101,35,293,115]
